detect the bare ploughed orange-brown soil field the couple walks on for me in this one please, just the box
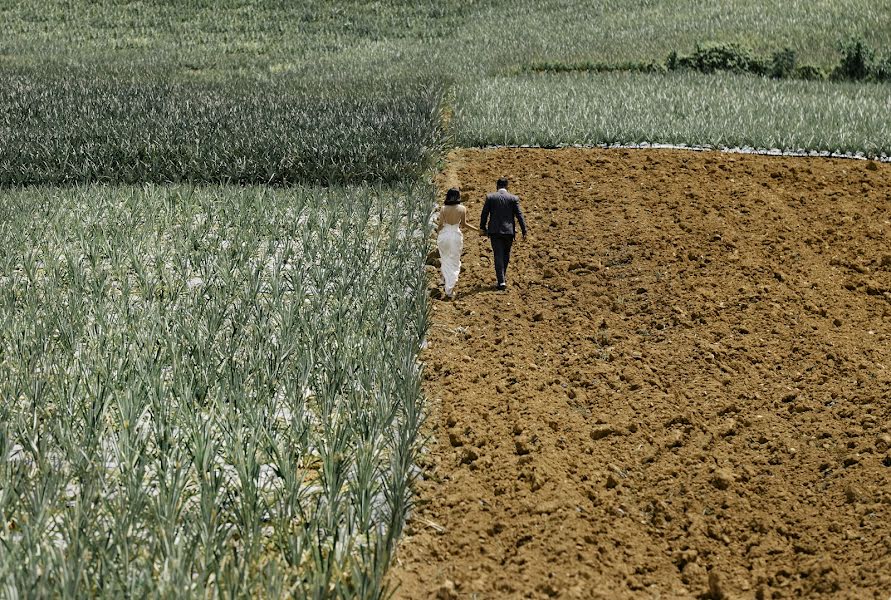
[392,149,891,600]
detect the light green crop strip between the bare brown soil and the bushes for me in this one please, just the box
[454,72,891,156]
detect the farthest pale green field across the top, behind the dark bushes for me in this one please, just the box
[0,0,891,73]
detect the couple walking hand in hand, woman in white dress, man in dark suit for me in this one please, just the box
[436,177,526,298]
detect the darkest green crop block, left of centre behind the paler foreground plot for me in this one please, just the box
[0,68,445,186]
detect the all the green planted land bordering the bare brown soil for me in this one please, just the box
[0,0,891,598]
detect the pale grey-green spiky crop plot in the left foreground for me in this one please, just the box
[0,186,432,598]
